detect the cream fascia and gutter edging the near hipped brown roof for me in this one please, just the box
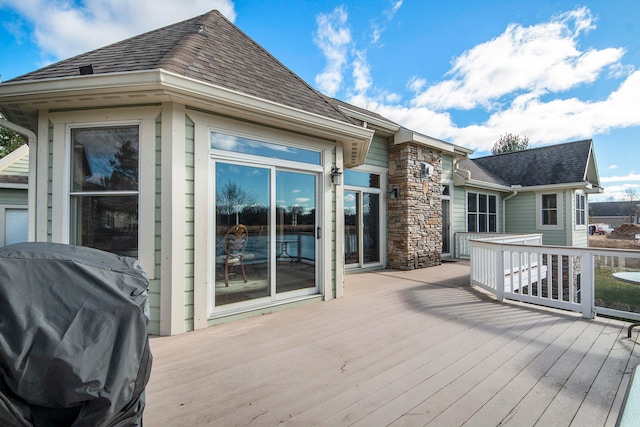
[0,69,374,166]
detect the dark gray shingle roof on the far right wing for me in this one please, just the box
[460,140,592,187]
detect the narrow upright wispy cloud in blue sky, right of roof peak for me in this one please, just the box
[314,7,351,96]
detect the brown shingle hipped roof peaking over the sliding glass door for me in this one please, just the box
[6,10,352,123]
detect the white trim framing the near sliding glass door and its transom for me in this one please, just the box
[187,110,332,329]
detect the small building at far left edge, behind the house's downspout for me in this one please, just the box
[0,145,29,246]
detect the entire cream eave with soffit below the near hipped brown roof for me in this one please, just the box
[0,69,374,167]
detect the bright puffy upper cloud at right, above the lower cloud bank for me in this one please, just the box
[412,8,624,110]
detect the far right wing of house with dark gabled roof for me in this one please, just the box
[454,140,603,251]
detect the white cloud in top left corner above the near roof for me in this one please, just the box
[2,0,236,61]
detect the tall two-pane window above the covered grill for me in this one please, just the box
[70,125,140,257]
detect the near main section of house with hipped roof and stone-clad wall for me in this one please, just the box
[0,11,597,335]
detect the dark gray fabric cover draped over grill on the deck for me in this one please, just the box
[0,243,151,426]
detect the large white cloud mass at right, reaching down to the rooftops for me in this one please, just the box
[338,8,640,156]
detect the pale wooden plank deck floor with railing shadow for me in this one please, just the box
[144,263,640,427]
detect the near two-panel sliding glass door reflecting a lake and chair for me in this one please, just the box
[213,161,320,308]
